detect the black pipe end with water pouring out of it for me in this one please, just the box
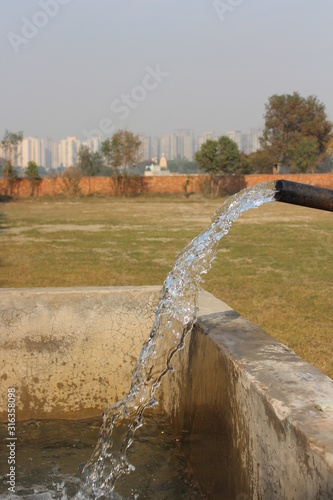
[274,179,333,212]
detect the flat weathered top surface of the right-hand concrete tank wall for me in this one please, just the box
[197,310,333,454]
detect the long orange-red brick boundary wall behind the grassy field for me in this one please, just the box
[0,173,333,198]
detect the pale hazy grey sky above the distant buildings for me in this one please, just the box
[0,0,333,139]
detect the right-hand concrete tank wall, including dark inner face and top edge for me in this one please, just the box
[179,311,333,500]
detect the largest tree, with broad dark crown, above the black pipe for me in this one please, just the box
[261,92,332,171]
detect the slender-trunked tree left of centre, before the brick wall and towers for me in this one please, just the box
[102,130,141,193]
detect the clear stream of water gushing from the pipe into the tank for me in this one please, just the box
[75,183,275,500]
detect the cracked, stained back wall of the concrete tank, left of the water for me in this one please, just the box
[0,287,160,421]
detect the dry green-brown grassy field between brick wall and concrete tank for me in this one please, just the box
[0,197,333,378]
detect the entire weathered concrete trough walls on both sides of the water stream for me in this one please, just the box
[0,287,333,500]
